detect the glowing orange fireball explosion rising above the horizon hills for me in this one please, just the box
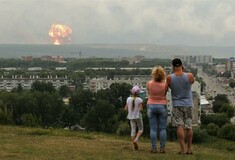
[48,24,72,45]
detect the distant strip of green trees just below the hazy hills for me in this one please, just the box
[0,58,171,70]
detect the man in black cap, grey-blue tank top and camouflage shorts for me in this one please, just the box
[167,58,194,154]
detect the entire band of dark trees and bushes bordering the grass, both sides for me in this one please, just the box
[0,82,235,143]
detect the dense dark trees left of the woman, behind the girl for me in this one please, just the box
[0,82,151,135]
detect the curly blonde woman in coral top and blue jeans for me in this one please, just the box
[147,66,168,153]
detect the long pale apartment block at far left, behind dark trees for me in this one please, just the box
[0,75,69,91]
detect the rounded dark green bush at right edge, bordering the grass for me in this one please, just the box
[218,124,235,141]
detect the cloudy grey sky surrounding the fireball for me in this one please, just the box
[0,0,235,46]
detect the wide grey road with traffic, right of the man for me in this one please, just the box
[198,68,235,106]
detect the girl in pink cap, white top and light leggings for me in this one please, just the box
[125,86,144,150]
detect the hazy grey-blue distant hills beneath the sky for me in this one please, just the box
[0,43,235,59]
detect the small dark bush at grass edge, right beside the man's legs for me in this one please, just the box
[193,128,209,143]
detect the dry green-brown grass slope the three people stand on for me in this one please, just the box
[0,126,235,160]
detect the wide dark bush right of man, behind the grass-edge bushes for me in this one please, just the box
[201,113,230,127]
